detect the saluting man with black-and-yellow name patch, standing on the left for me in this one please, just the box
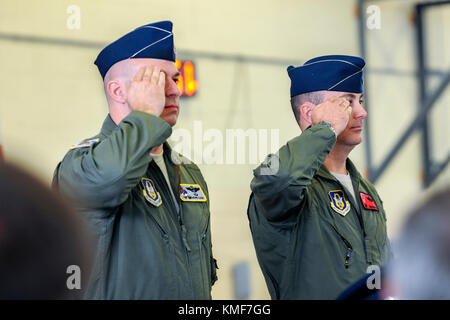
[53,21,217,299]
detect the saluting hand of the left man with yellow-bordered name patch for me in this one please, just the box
[127,66,166,117]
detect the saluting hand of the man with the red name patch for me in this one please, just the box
[311,97,352,136]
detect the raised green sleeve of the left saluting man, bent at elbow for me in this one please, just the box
[53,111,172,208]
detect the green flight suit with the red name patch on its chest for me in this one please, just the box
[247,124,390,299]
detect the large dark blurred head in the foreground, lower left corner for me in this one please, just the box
[0,162,91,300]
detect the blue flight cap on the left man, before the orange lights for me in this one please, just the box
[94,21,175,78]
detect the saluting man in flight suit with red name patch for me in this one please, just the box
[248,55,390,299]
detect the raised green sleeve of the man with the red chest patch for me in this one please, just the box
[250,125,336,221]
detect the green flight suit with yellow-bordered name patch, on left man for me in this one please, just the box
[53,111,217,299]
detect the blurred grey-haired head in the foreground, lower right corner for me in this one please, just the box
[381,187,450,300]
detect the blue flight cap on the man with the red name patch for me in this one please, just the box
[287,55,366,98]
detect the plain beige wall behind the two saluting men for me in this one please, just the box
[0,0,450,299]
